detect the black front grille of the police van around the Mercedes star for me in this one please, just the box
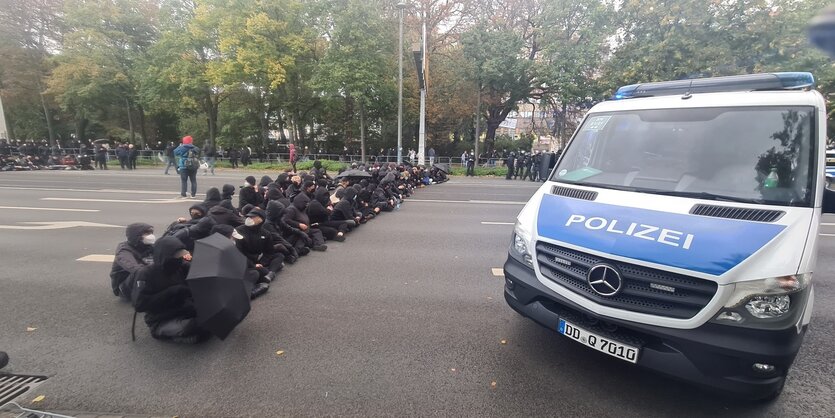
[536,242,717,319]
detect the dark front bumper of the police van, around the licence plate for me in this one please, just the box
[504,253,805,399]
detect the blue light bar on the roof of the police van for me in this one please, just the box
[612,72,815,100]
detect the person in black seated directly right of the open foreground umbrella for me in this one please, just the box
[233,208,284,299]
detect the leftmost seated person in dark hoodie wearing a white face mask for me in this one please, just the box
[110,223,156,301]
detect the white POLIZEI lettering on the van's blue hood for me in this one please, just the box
[565,215,695,250]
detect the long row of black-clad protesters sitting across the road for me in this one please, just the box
[110,164,438,343]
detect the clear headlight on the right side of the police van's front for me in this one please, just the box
[714,273,812,328]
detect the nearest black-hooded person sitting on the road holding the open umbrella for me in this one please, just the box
[134,237,210,344]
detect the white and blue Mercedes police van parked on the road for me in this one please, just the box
[504,73,835,399]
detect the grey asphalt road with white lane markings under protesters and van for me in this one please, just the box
[0,170,835,417]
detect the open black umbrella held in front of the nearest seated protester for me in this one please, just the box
[186,233,251,340]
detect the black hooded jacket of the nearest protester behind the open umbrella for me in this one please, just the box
[134,237,196,325]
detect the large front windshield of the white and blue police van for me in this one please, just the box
[552,107,815,207]
